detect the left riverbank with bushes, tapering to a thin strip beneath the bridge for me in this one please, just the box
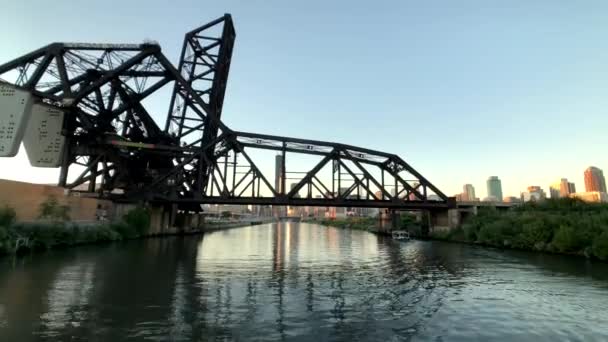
[0,204,274,255]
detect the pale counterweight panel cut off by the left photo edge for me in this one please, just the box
[0,84,32,157]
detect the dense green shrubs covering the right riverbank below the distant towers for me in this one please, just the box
[430,199,608,261]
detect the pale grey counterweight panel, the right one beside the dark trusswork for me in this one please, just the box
[23,103,65,167]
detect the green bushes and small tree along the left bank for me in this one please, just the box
[0,199,150,254]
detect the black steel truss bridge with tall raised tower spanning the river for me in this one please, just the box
[0,14,453,211]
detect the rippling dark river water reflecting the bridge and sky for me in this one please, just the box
[0,223,608,341]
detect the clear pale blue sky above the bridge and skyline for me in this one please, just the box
[0,0,608,197]
